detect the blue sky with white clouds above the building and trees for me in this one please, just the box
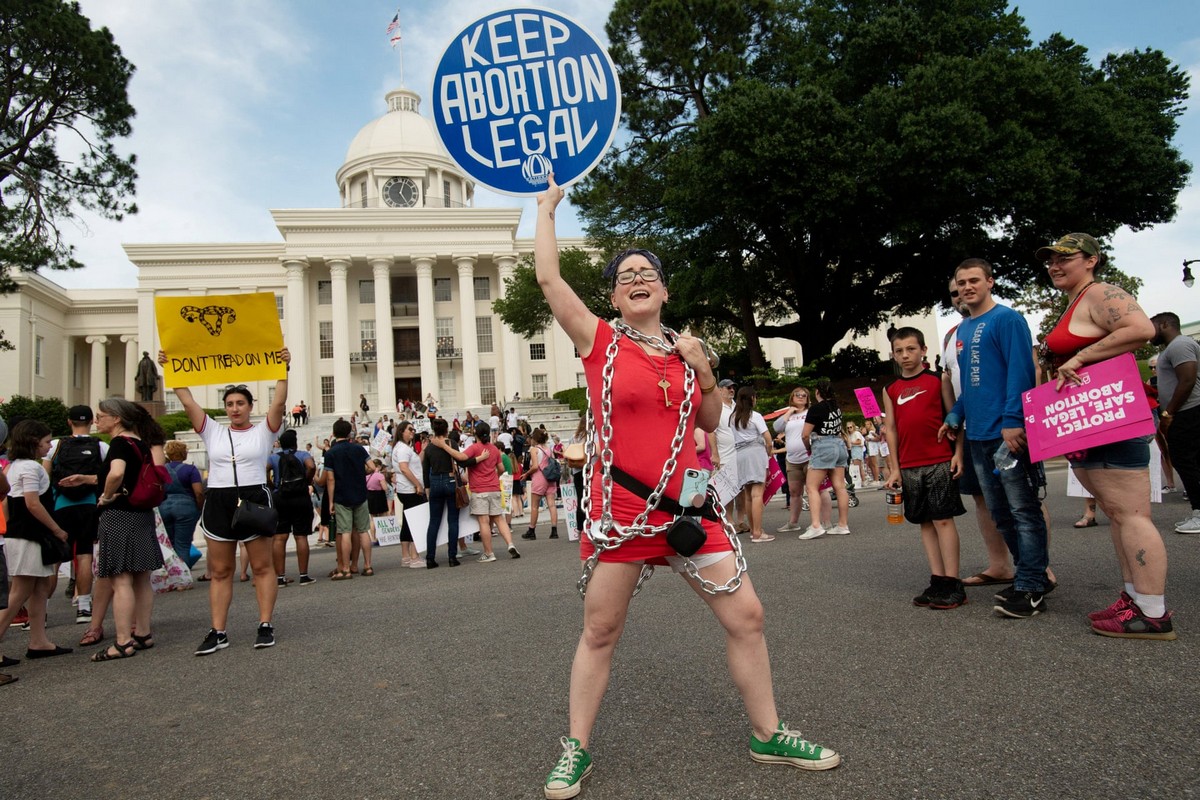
[60,0,1200,321]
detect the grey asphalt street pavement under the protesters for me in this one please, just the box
[0,469,1200,800]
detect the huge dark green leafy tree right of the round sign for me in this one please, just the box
[572,0,1190,368]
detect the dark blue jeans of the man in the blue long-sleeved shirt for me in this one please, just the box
[967,439,1050,591]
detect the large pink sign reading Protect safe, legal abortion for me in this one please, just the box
[1021,353,1154,461]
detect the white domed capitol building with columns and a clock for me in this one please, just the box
[0,89,940,416]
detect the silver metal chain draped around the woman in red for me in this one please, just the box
[578,321,746,597]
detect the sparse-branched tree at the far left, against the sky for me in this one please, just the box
[0,0,137,291]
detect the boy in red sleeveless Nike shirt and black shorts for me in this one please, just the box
[883,327,967,608]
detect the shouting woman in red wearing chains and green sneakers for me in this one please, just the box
[534,175,841,800]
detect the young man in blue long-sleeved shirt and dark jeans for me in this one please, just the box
[942,258,1054,619]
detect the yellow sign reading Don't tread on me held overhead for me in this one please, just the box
[154,291,287,389]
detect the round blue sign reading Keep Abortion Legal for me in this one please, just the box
[433,7,620,197]
